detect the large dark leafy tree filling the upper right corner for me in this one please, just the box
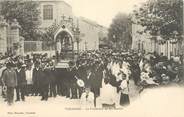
[134,0,183,40]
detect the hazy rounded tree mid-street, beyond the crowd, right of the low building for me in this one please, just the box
[108,13,132,50]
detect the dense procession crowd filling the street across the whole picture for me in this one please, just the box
[0,50,183,108]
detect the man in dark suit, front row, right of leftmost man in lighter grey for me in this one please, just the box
[16,63,27,101]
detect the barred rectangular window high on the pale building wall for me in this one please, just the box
[43,5,53,20]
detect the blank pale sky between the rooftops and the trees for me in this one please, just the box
[64,0,146,27]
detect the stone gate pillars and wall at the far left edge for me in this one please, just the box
[0,16,24,55]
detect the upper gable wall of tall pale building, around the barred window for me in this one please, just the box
[35,0,74,29]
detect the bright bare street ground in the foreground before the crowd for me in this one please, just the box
[0,80,184,117]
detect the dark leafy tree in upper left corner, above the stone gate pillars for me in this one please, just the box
[0,0,40,40]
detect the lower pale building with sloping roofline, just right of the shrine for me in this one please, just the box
[79,17,107,50]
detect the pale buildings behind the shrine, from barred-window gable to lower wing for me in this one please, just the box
[37,0,107,51]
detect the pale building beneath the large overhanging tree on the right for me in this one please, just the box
[132,19,179,58]
